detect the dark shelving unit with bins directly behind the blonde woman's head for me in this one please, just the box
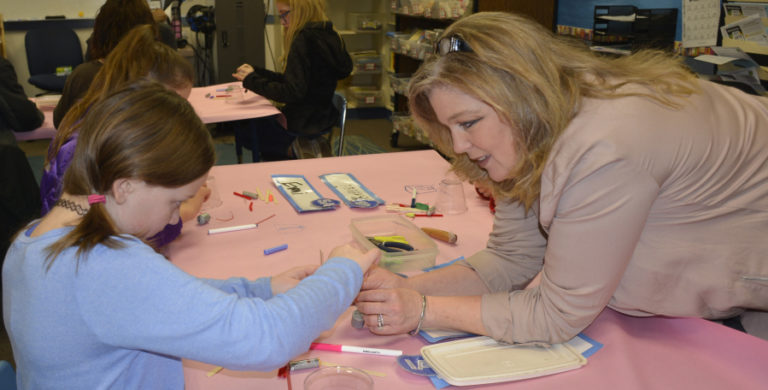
[387,0,556,147]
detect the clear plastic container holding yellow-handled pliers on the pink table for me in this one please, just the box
[349,215,437,272]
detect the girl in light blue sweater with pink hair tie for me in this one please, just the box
[3,83,378,389]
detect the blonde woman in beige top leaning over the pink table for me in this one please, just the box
[357,13,768,343]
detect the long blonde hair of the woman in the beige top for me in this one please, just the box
[408,12,697,208]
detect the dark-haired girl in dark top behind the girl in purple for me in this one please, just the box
[53,0,155,129]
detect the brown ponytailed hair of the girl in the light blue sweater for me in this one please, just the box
[47,81,215,268]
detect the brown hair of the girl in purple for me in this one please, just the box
[46,24,195,165]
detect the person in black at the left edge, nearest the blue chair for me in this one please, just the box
[0,57,44,145]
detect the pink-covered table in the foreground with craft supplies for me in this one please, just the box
[169,150,768,390]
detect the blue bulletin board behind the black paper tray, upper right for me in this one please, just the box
[557,0,683,41]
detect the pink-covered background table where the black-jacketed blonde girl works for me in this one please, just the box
[13,82,286,141]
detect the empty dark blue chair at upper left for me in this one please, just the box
[24,27,83,93]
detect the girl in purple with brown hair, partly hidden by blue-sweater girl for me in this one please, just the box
[40,25,204,247]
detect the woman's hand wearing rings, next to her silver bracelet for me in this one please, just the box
[355,288,421,335]
